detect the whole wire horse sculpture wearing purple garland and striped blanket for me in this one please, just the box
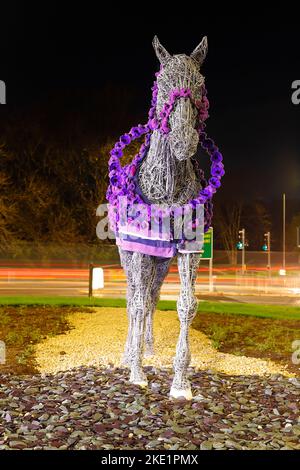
[107,36,225,399]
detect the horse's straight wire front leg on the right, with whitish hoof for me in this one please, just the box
[170,253,200,400]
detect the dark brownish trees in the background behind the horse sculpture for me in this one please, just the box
[0,87,300,262]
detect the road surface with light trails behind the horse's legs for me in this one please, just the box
[0,266,300,305]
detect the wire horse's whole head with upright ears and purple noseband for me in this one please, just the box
[153,36,208,160]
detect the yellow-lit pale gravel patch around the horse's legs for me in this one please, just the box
[35,308,290,376]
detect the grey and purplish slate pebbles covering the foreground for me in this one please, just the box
[0,367,300,450]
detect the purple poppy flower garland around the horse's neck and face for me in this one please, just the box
[106,72,225,232]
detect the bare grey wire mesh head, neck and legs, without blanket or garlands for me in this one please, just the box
[108,38,220,399]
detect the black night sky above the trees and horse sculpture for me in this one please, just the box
[0,2,300,199]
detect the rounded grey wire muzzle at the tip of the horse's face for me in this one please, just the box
[169,126,199,160]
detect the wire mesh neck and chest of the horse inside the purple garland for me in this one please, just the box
[139,131,198,204]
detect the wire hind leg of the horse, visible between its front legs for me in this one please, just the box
[145,258,172,357]
